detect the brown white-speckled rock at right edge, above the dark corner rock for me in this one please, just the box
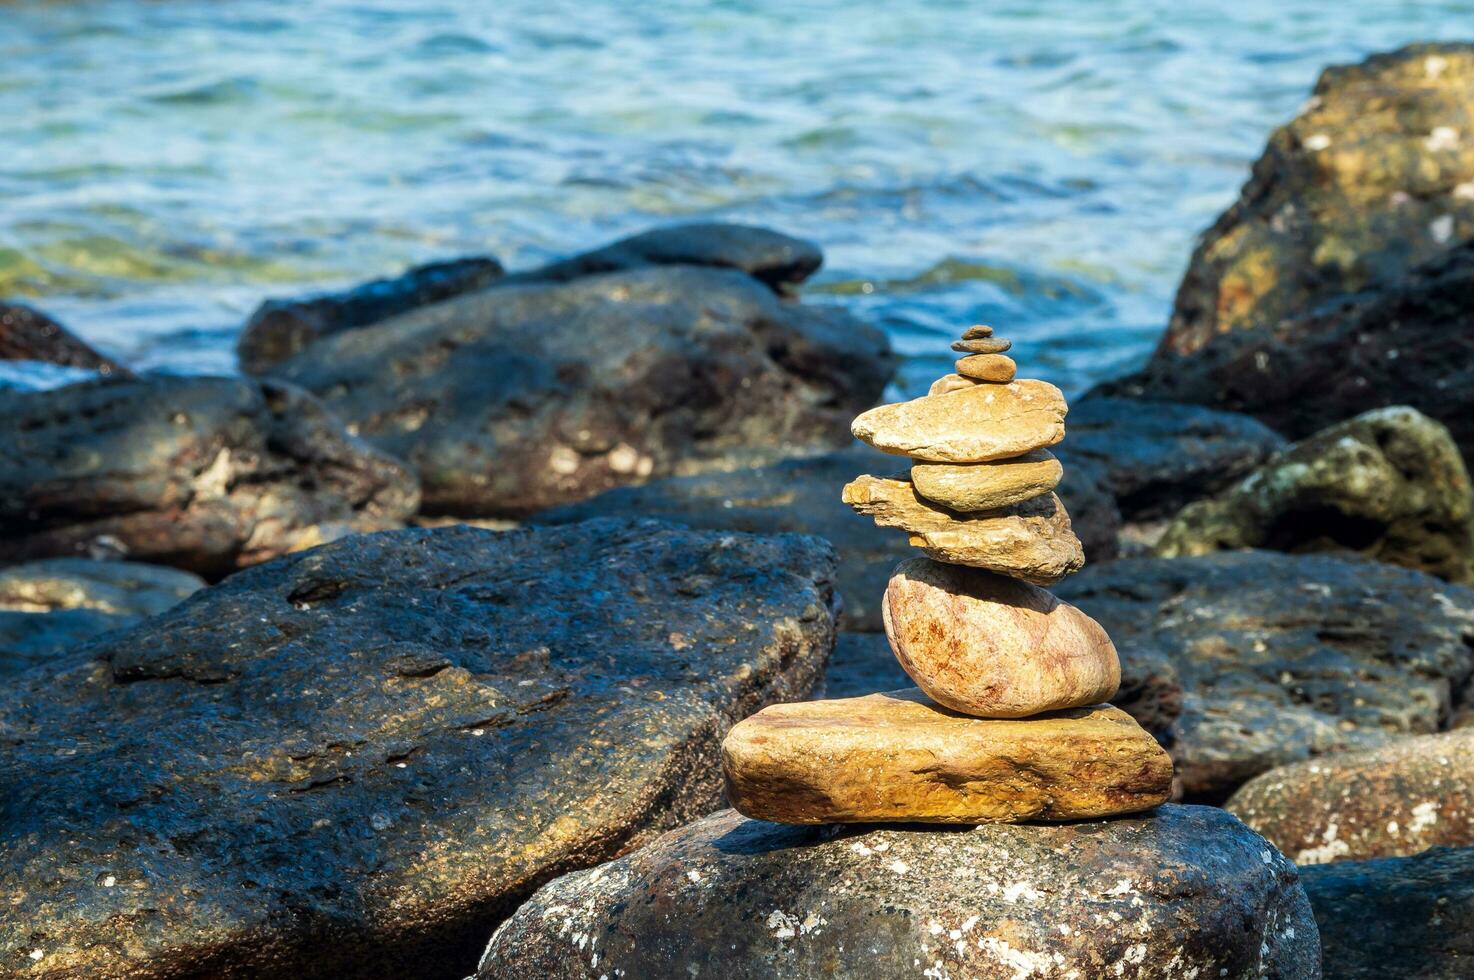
[1228,728,1474,865]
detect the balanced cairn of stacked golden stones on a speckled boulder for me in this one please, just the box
[722,326,1172,824]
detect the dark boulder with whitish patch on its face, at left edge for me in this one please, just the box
[0,376,419,576]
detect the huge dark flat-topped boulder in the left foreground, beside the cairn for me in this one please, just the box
[0,522,834,979]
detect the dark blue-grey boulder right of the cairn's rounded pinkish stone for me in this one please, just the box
[1057,551,1474,800]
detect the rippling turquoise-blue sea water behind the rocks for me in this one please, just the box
[0,0,1474,392]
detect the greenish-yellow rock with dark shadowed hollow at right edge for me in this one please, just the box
[1157,408,1474,582]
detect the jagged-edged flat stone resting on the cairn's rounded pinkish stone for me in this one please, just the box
[845,476,1085,585]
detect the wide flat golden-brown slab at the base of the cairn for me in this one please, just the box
[722,688,1172,824]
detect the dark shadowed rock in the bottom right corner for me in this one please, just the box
[1300,847,1474,980]
